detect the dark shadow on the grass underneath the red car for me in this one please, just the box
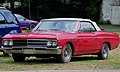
[11,56,98,64]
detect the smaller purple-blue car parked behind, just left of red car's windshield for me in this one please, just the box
[14,14,38,29]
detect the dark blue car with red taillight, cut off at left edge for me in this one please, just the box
[0,8,22,54]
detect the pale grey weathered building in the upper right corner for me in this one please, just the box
[101,0,120,25]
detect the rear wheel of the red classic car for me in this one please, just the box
[98,43,109,60]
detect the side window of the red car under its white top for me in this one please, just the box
[79,21,96,32]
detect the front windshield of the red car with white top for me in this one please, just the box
[36,20,77,31]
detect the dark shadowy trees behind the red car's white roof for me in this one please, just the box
[8,0,102,20]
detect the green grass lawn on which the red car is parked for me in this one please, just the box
[0,26,120,71]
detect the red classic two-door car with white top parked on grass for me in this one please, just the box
[2,18,119,63]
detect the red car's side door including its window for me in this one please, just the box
[78,21,97,54]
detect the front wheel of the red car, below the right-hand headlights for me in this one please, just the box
[59,43,72,63]
